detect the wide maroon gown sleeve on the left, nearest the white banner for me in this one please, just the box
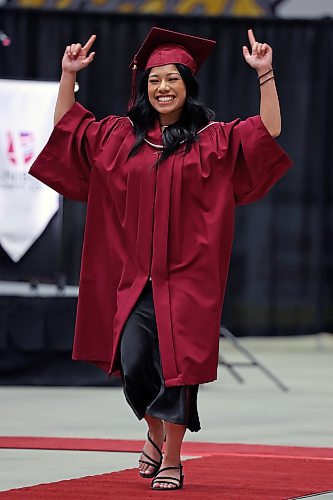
[29,102,119,201]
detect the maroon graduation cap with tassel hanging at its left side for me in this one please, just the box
[129,27,216,108]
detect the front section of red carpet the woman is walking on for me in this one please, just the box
[0,455,333,500]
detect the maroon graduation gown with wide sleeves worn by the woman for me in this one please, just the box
[30,103,291,387]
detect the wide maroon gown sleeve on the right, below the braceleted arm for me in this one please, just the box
[229,115,292,205]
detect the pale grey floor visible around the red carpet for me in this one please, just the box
[0,334,333,499]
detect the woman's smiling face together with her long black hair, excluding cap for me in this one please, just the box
[128,59,215,165]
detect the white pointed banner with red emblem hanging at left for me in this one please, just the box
[0,80,59,262]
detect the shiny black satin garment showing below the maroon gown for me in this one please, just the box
[120,281,200,432]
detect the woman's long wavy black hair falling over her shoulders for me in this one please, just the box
[128,64,215,165]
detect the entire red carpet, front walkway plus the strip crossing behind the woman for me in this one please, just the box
[0,437,333,500]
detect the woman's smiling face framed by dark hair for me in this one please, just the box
[148,64,186,125]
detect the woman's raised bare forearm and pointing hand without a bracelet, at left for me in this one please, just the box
[54,35,96,125]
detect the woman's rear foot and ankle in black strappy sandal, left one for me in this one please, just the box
[139,422,164,478]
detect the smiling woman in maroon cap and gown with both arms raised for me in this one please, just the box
[30,28,291,489]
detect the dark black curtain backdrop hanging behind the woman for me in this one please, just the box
[0,8,333,335]
